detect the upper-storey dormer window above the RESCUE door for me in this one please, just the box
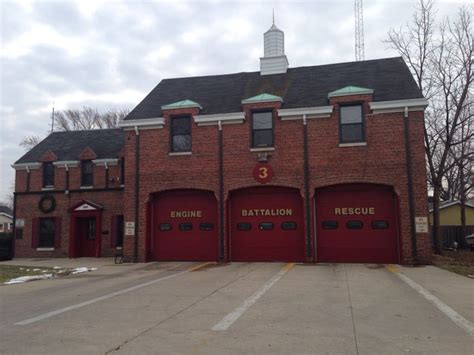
[339,105,365,143]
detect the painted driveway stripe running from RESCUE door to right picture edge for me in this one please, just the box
[385,265,474,336]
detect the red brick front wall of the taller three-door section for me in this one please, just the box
[124,95,431,263]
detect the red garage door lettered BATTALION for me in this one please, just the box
[230,187,305,261]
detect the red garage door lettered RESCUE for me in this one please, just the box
[315,184,399,263]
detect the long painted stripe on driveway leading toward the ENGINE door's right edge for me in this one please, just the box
[15,263,212,325]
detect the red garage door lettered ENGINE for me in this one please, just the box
[151,190,218,261]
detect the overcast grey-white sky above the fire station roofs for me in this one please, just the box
[0,0,469,200]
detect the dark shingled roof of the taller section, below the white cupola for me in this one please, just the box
[125,57,423,120]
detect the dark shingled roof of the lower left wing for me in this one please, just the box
[15,128,124,164]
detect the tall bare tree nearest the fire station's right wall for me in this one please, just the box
[386,0,474,253]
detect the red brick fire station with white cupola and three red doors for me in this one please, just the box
[13,25,432,264]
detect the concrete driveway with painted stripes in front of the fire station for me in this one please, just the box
[0,262,474,354]
